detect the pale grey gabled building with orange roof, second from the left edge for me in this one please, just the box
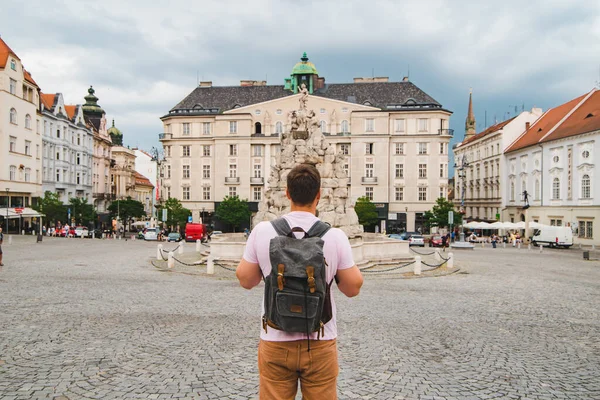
[41,93,94,204]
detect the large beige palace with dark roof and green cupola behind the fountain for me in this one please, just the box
[159,53,452,232]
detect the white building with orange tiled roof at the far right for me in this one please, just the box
[503,89,600,245]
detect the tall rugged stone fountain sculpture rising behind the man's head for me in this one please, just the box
[253,84,363,239]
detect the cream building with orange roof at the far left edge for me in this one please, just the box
[0,39,42,214]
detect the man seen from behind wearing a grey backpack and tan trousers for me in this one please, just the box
[236,164,363,400]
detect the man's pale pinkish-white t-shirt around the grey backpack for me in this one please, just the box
[244,211,354,342]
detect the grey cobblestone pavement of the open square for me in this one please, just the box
[0,238,600,399]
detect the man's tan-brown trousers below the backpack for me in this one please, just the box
[258,340,339,400]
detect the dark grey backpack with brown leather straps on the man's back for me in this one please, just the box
[263,218,332,338]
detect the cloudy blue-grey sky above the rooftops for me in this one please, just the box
[0,0,600,155]
